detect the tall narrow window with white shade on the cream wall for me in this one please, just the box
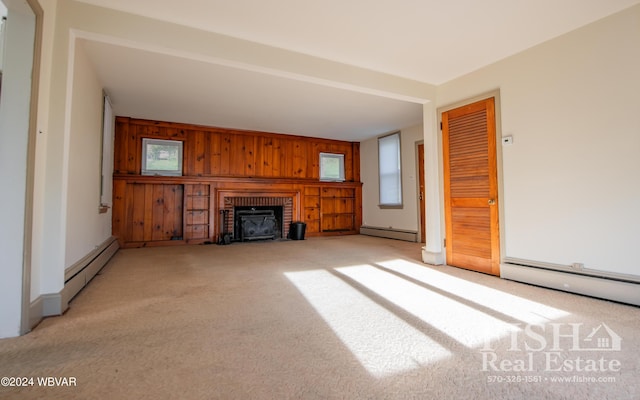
[378,132,402,208]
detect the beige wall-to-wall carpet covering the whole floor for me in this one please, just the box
[0,236,640,399]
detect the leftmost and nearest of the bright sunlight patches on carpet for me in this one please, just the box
[285,270,451,377]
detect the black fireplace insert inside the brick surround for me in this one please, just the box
[233,206,282,242]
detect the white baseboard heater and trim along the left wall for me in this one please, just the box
[29,236,120,328]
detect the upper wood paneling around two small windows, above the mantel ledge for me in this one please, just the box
[114,117,360,182]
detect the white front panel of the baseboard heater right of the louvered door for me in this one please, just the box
[500,263,640,306]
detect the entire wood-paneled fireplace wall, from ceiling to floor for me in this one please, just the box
[113,117,362,247]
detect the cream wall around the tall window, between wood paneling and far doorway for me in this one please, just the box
[360,125,423,231]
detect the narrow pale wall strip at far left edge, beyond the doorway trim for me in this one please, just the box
[0,0,35,338]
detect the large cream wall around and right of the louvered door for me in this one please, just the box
[437,5,640,275]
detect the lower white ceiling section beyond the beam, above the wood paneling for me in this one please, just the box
[81,40,422,141]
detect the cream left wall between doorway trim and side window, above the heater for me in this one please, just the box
[31,1,111,301]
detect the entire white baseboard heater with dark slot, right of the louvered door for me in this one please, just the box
[500,258,640,306]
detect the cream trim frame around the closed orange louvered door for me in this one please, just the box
[436,89,506,274]
